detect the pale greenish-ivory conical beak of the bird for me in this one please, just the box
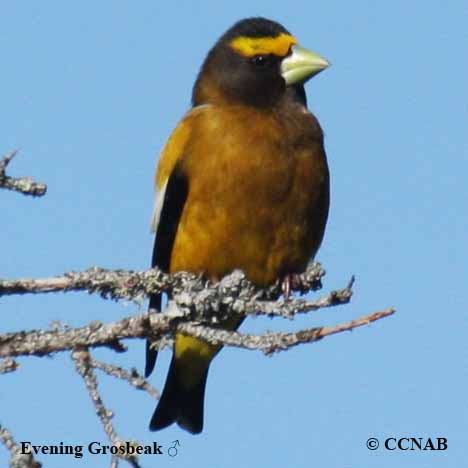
[281,45,330,86]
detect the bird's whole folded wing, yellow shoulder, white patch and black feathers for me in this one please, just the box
[145,110,196,377]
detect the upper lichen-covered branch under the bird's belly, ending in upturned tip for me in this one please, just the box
[0,263,346,320]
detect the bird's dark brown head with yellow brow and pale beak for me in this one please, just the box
[192,18,330,107]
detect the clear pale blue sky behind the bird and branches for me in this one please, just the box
[0,0,468,468]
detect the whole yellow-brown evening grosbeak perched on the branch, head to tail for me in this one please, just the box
[146,18,329,433]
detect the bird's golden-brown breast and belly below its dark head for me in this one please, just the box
[171,103,328,284]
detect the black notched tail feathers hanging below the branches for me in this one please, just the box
[149,356,208,434]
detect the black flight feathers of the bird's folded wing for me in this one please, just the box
[145,166,188,377]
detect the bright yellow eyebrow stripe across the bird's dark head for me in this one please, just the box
[229,33,297,57]
